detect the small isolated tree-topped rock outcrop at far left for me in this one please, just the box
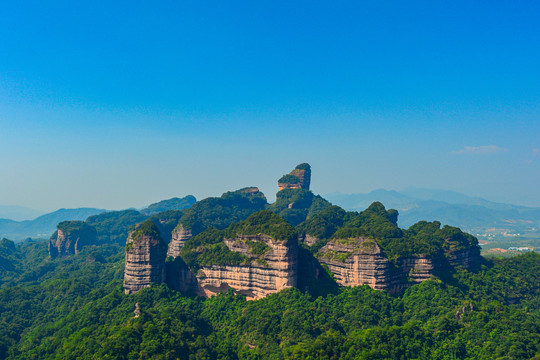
[49,221,96,258]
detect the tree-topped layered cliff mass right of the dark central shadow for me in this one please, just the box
[314,203,480,293]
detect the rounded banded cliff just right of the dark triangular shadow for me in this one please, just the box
[318,237,391,290]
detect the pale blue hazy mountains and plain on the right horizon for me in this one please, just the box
[324,188,540,236]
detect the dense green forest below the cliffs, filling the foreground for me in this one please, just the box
[0,236,540,360]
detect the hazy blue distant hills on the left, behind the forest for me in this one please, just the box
[0,195,196,240]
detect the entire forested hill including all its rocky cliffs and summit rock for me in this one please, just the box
[0,164,540,360]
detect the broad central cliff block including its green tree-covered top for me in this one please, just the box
[181,211,298,299]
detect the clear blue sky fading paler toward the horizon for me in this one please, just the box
[0,0,540,210]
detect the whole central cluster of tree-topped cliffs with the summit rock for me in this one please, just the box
[118,164,481,299]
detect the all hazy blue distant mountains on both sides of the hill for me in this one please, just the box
[5,188,540,240]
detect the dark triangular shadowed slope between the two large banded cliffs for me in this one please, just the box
[297,246,339,297]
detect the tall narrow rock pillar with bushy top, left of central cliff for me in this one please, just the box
[124,220,167,294]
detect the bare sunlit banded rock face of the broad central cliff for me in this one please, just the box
[196,234,298,300]
